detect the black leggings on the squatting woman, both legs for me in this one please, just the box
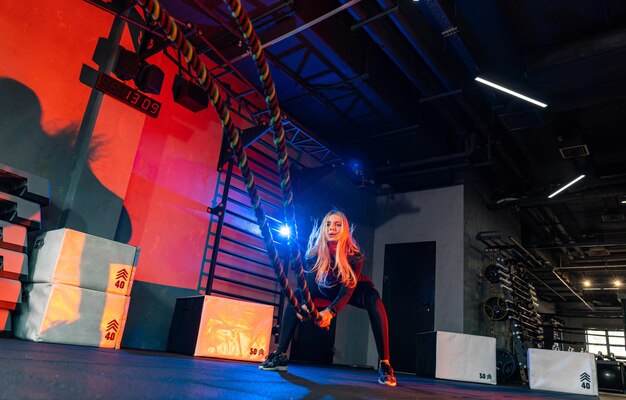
[278,274,389,360]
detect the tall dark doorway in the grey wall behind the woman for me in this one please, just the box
[383,242,436,373]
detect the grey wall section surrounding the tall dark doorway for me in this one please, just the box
[368,186,463,365]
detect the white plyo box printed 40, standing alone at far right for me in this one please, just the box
[528,349,598,396]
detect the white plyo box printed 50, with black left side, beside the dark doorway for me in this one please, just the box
[416,331,497,385]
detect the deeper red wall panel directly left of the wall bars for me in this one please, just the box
[124,55,222,289]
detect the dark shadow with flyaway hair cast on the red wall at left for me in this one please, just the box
[0,77,132,243]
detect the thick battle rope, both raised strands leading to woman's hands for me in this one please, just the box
[138,0,320,320]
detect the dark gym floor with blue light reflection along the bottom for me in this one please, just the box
[0,339,608,400]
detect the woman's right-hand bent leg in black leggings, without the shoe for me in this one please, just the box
[348,282,389,360]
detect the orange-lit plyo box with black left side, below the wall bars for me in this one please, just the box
[168,296,274,361]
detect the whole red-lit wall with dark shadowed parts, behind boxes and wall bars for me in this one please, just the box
[0,0,280,349]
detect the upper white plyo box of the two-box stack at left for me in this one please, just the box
[29,228,139,296]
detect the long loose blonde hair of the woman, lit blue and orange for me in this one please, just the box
[306,210,361,288]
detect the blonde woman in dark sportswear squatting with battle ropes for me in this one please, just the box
[259,210,396,386]
